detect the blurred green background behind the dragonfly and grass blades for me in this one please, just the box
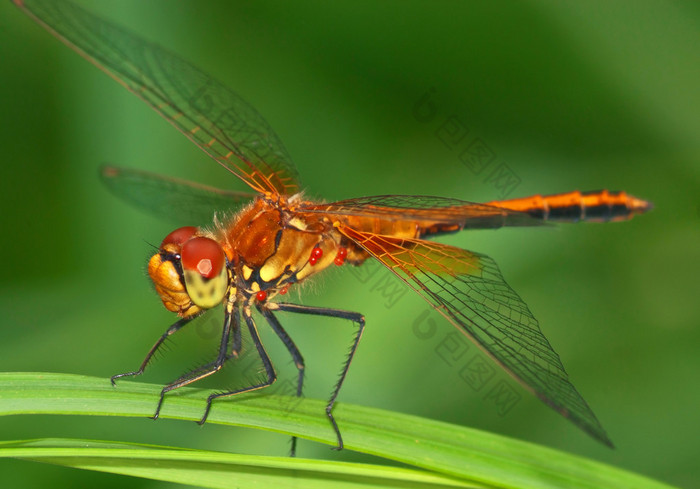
[0,0,700,487]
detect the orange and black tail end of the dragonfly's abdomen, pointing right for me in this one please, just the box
[487,190,652,222]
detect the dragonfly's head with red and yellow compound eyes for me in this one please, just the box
[148,226,229,317]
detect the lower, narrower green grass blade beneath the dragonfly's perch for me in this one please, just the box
[0,439,476,489]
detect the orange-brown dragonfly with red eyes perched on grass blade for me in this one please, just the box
[13,0,652,454]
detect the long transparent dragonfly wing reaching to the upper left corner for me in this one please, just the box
[14,0,299,194]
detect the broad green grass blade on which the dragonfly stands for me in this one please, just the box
[0,373,680,489]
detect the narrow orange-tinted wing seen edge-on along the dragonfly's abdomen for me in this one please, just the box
[300,195,546,229]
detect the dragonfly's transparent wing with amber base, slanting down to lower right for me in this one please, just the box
[339,227,612,446]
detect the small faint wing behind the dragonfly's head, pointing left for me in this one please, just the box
[100,166,258,226]
